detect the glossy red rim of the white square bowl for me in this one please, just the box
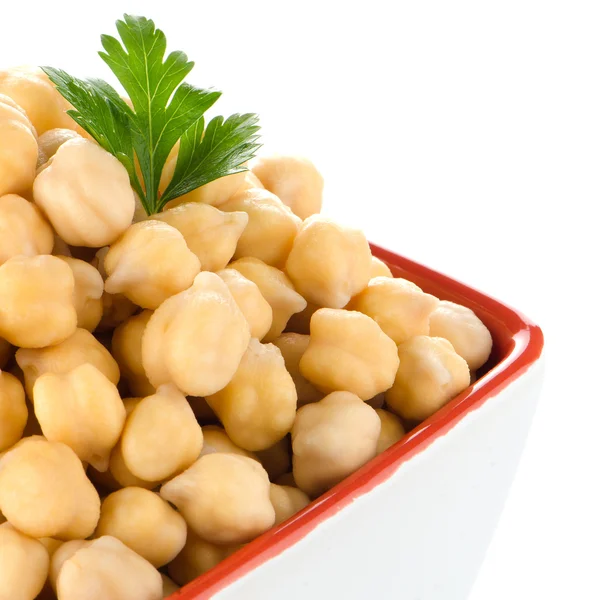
[169,244,544,600]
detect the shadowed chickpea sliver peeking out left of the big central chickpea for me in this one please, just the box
[111,310,155,396]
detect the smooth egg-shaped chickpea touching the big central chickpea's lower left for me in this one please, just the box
[121,385,202,481]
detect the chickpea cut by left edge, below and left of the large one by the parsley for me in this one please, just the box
[0,194,54,265]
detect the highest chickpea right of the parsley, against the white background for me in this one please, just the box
[251,154,323,219]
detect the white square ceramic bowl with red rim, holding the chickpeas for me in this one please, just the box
[169,245,544,600]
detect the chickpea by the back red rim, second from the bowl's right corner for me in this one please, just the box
[347,277,439,344]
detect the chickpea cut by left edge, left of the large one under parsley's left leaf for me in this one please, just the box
[0,94,38,196]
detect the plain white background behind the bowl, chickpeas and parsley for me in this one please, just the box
[0,0,600,600]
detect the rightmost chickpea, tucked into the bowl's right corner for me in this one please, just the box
[429,300,493,373]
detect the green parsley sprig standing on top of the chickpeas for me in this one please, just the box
[43,15,259,215]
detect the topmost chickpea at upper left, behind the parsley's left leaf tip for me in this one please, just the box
[0,66,76,134]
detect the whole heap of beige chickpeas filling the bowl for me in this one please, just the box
[0,68,492,600]
